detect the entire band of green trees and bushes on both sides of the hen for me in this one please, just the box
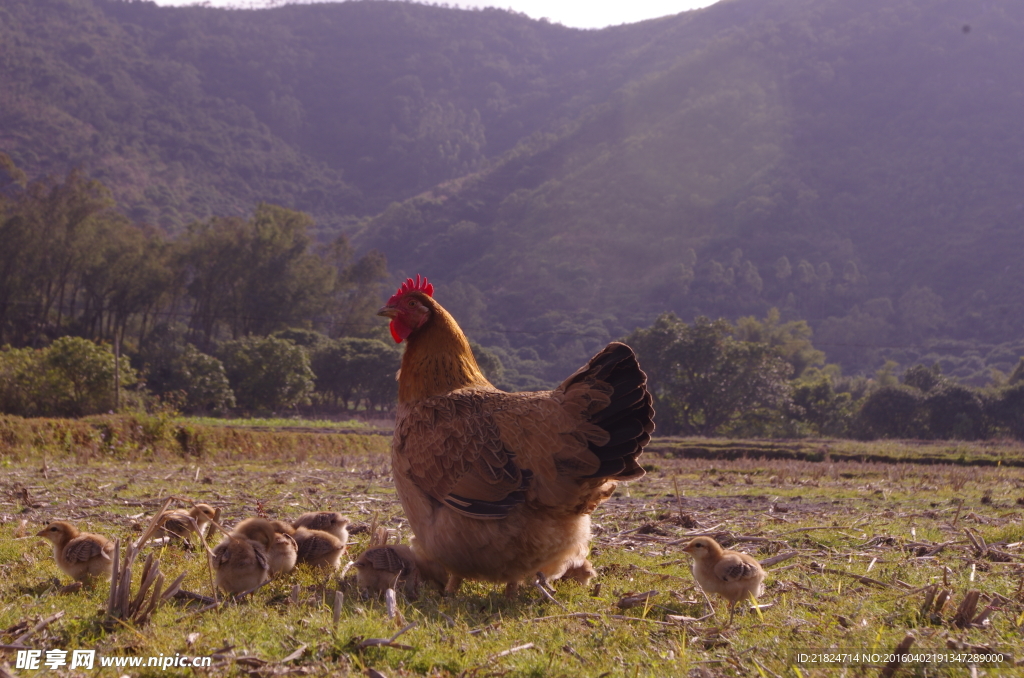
[0,160,1024,439]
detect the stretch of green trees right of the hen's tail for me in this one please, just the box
[626,309,1024,440]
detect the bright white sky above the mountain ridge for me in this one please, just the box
[149,0,716,29]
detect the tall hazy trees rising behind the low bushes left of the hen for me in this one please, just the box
[0,154,387,350]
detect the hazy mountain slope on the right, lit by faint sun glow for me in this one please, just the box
[362,0,1024,378]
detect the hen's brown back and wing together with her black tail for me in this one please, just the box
[395,343,654,519]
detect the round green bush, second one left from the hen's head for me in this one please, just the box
[221,337,314,412]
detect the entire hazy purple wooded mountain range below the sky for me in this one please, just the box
[0,0,1024,377]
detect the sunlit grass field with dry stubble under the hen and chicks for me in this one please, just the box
[0,422,1024,678]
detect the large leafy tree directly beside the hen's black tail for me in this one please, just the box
[626,313,790,435]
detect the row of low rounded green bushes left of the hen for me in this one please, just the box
[0,331,400,417]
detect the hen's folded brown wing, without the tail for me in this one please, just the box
[394,389,531,519]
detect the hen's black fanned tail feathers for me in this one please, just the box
[561,342,654,480]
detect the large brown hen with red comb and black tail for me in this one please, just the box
[378,276,654,595]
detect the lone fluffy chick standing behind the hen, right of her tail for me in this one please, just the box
[683,537,765,624]
